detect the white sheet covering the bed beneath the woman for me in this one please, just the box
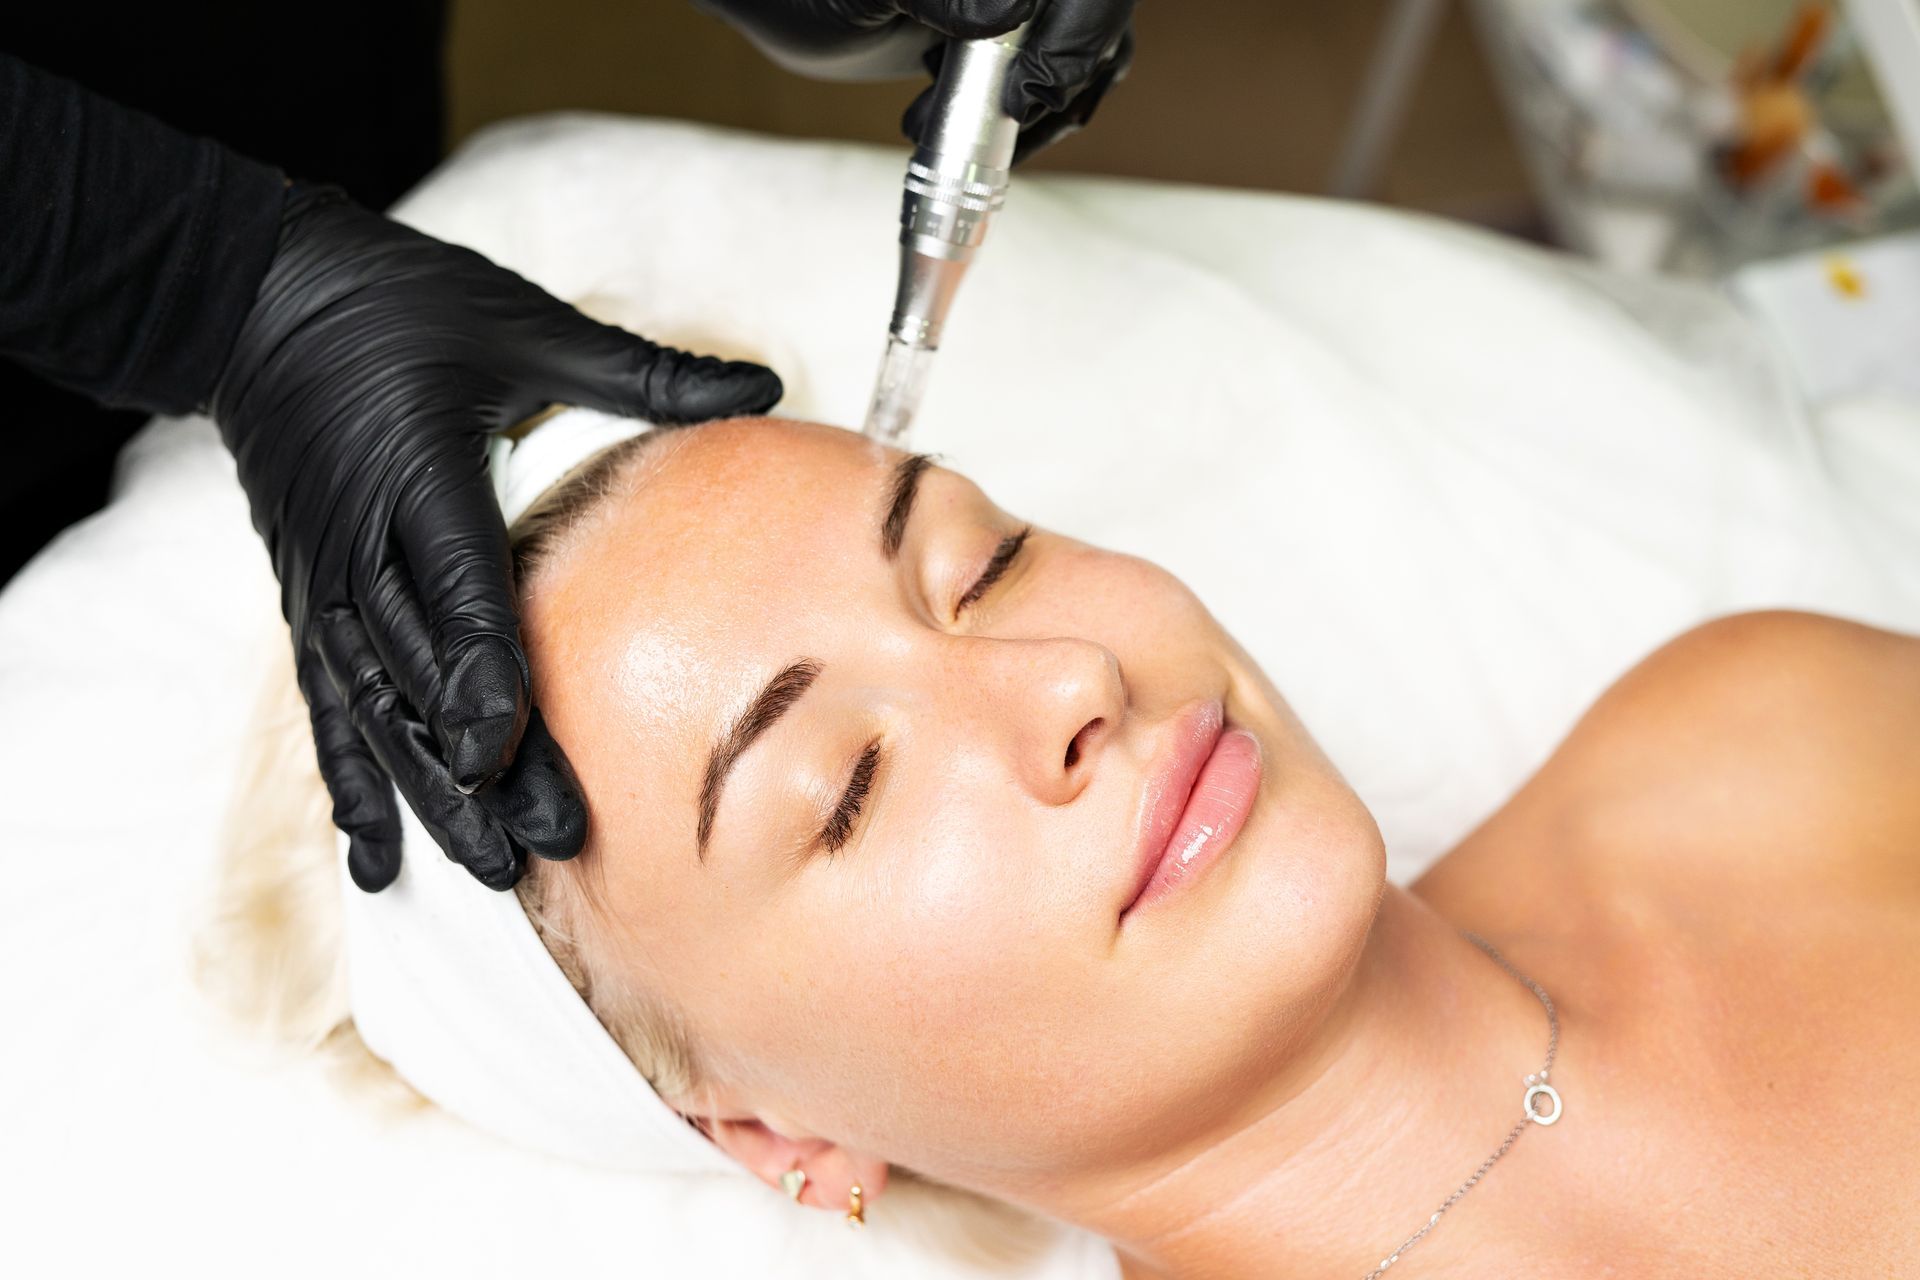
[0,117,1920,1280]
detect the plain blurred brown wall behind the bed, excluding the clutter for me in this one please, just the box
[447,0,1528,221]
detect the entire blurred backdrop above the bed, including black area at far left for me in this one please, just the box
[0,0,1920,276]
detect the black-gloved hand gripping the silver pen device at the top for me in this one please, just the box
[699,0,1135,163]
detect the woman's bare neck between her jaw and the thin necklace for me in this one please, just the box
[1050,887,1567,1276]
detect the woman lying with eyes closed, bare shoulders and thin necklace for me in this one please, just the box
[217,422,1920,1278]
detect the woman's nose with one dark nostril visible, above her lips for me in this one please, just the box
[979,637,1127,804]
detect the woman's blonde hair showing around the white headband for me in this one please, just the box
[194,432,1050,1268]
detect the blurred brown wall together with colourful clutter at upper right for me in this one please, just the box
[445,0,1920,274]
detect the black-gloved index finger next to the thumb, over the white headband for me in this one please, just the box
[387,449,532,793]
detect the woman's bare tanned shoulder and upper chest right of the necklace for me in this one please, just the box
[1415,612,1920,1276]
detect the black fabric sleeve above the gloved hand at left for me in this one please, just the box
[0,54,286,413]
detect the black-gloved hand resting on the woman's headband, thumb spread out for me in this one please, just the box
[222,186,781,890]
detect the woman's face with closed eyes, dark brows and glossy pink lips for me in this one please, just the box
[526,422,1384,1199]
